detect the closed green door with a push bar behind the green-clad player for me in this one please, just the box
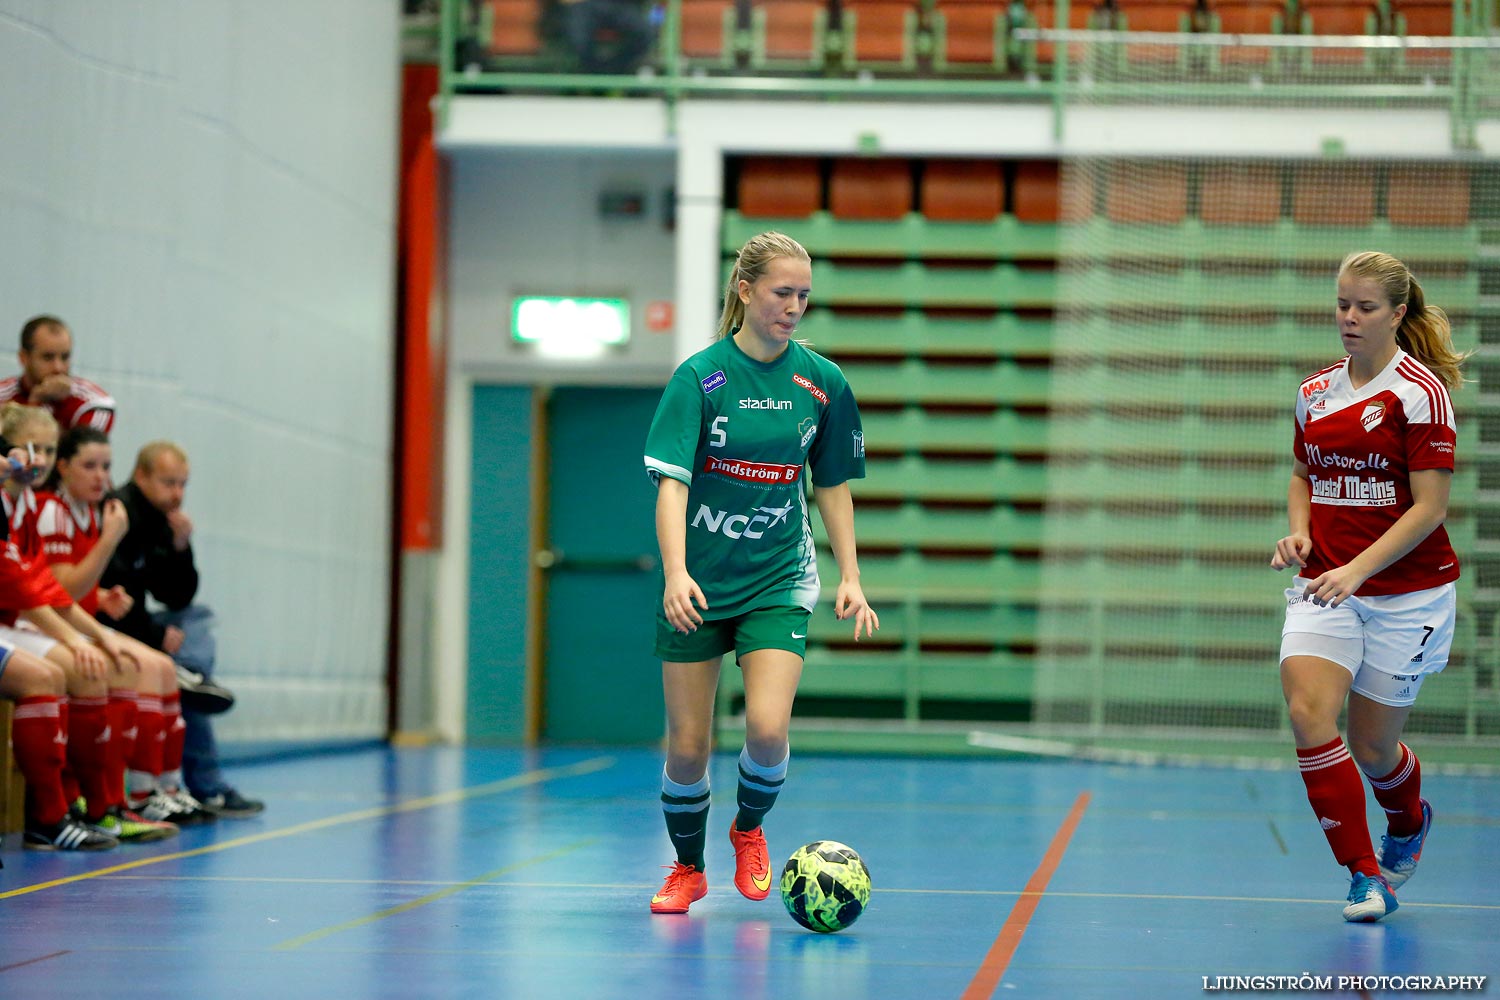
[542,388,665,744]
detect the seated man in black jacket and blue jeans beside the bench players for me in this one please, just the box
[99,441,266,816]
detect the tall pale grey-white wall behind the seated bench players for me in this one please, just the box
[0,0,399,739]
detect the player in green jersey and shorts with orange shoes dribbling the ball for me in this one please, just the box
[645,232,881,913]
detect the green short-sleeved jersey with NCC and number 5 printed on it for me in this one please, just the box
[645,337,864,618]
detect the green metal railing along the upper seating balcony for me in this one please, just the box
[438,0,1500,141]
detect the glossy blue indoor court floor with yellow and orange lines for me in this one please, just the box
[0,747,1500,1000]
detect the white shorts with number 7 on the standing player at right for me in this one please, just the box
[1281,577,1458,708]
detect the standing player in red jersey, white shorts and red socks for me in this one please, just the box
[1271,252,1466,921]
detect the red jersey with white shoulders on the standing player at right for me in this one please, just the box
[1293,349,1458,597]
